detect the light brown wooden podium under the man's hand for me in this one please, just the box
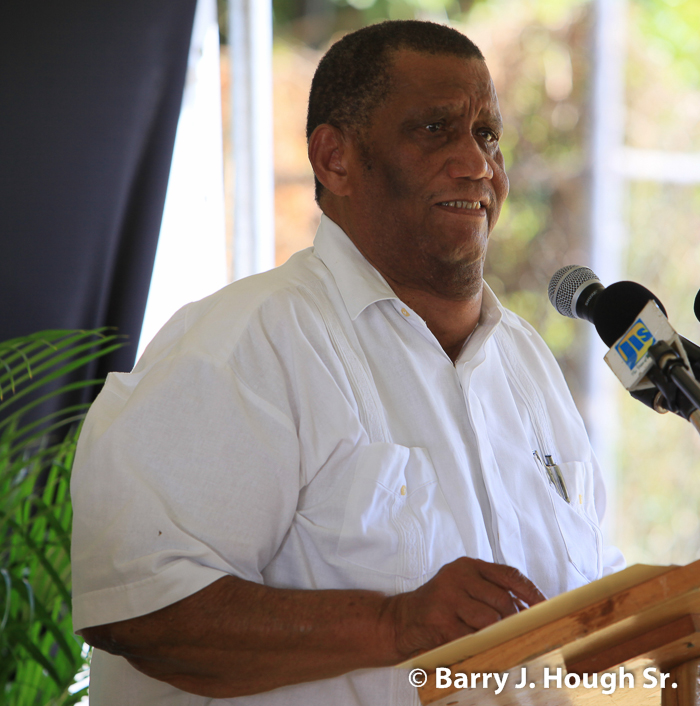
[399,561,700,706]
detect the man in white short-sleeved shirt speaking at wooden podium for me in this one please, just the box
[73,22,620,706]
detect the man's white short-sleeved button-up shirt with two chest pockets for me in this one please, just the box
[72,216,622,706]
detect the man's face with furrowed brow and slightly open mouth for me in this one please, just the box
[349,50,508,299]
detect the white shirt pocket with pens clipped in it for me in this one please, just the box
[549,461,603,581]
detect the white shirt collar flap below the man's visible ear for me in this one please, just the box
[314,214,398,321]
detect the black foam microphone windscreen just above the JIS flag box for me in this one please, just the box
[593,282,666,348]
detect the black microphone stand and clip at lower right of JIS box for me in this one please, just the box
[647,341,700,434]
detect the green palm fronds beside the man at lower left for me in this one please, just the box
[0,329,123,706]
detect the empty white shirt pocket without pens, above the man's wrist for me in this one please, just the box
[338,443,464,579]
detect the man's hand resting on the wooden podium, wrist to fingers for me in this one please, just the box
[388,557,546,660]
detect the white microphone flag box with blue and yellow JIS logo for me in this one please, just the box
[605,300,690,391]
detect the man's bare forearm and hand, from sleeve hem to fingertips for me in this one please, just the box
[80,558,544,698]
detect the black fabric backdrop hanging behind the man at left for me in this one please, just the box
[0,0,196,416]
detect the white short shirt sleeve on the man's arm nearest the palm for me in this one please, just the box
[71,354,300,630]
